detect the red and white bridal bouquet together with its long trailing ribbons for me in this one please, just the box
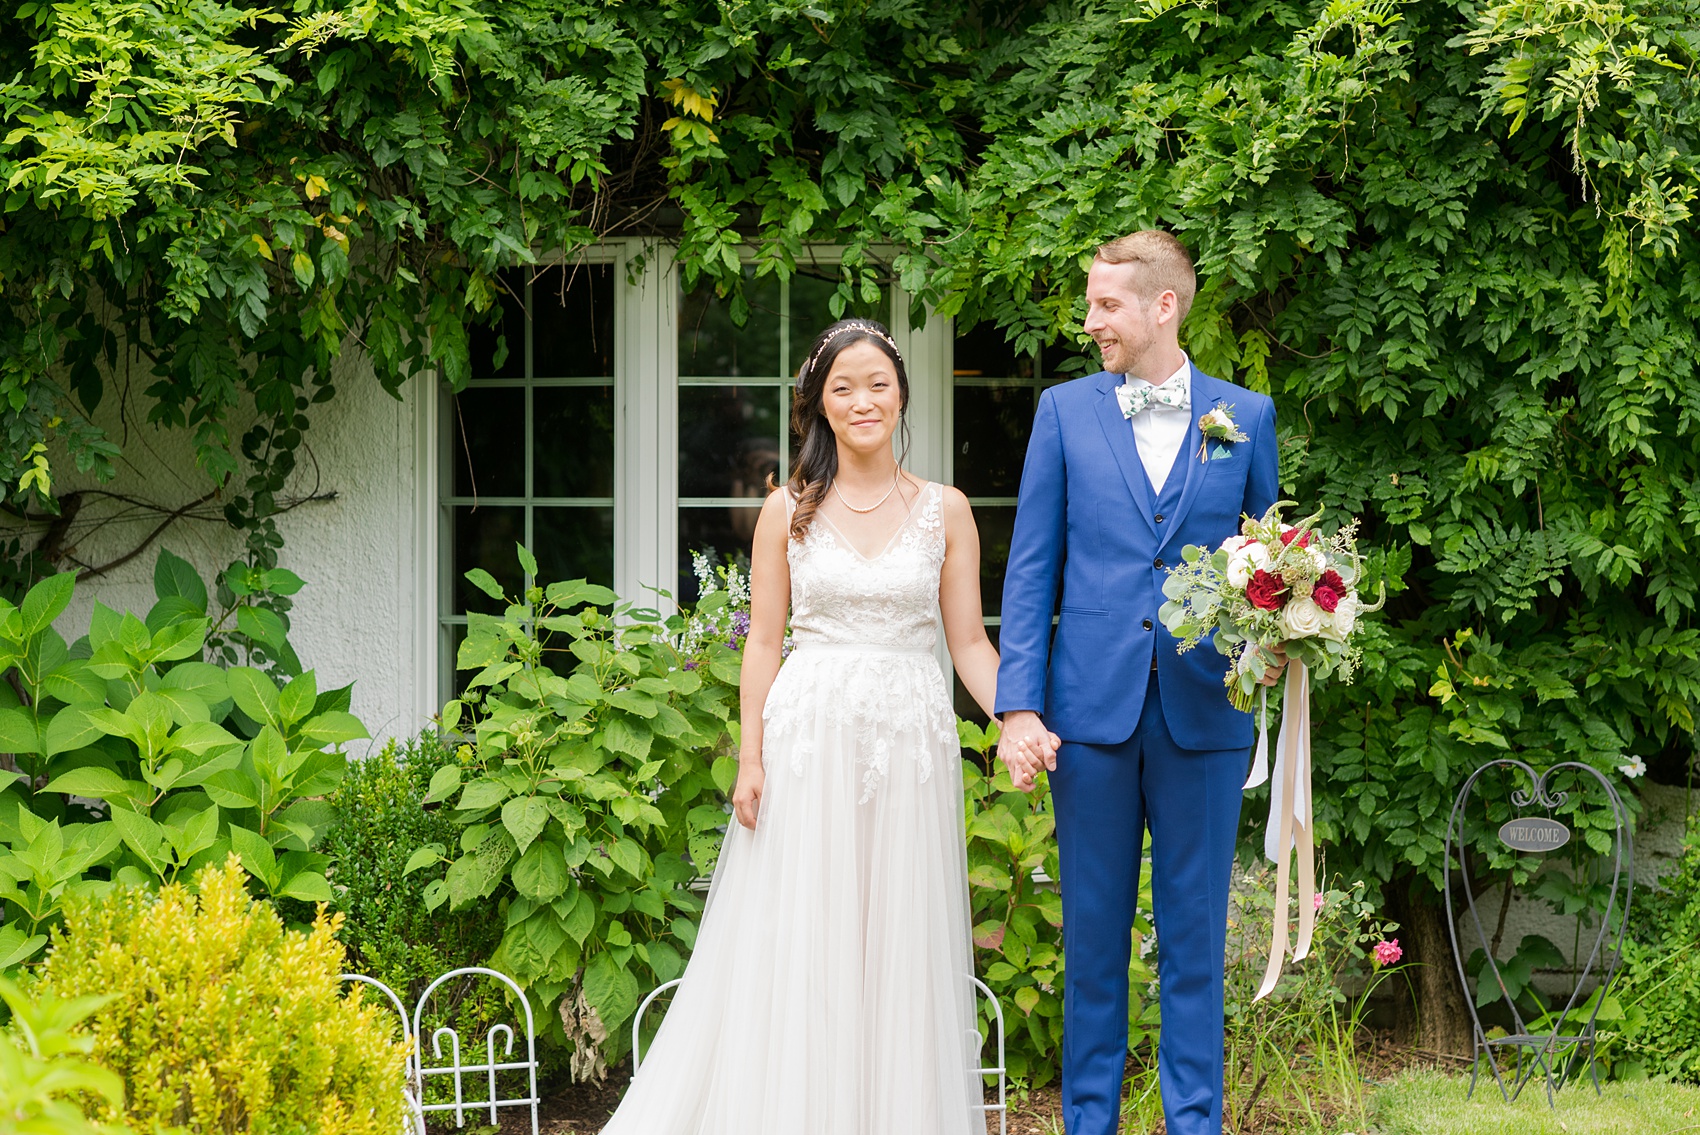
[1158,499,1387,999]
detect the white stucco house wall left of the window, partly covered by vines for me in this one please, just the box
[0,350,437,754]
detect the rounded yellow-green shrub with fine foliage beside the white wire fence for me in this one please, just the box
[41,856,403,1135]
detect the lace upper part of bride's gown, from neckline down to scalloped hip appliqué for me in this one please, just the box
[762,484,957,804]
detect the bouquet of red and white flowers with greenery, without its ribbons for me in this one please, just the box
[1158,501,1380,710]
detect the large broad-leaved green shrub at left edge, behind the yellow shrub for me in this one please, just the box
[0,552,366,968]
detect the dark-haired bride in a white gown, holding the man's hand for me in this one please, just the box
[604,319,1040,1135]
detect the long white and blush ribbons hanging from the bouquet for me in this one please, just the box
[1246,659,1316,1001]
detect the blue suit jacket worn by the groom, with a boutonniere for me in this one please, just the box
[996,367,1280,749]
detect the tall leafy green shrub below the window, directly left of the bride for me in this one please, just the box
[410,547,740,1077]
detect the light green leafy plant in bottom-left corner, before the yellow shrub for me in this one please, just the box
[0,977,124,1135]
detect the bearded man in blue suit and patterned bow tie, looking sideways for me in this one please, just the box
[998,231,1278,1135]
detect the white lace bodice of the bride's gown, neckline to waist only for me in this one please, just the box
[785,483,945,649]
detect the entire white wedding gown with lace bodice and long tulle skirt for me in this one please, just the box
[604,484,986,1135]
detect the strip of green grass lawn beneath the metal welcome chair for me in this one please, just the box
[1370,1072,1700,1135]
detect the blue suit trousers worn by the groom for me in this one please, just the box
[1051,675,1246,1135]
